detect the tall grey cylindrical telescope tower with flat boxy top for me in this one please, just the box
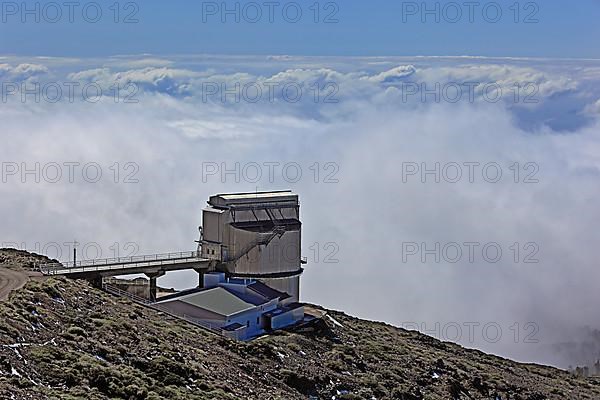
[200,191,305,301]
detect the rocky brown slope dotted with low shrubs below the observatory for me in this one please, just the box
[0,250,600,400]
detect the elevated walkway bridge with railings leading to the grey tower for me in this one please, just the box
[36,251,210,276]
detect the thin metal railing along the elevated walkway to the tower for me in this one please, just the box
[36,251,206,275]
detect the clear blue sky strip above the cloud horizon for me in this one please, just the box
[0,0,600,58]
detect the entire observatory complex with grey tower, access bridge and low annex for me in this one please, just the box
[38,191,314,340]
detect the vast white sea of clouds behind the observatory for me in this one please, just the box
[0,55,600,368]
